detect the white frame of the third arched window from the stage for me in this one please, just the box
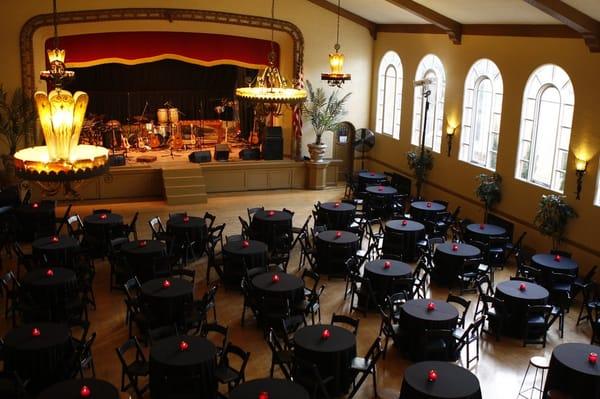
[459,58,504,171]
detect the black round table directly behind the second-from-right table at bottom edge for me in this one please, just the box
[400,299,458,360]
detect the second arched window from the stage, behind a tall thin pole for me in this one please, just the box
[410,54,446,152]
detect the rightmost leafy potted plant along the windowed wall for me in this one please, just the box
[533,194,577,249]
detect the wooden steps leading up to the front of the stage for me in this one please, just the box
[162,166,207,205]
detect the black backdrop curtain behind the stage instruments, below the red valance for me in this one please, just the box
[67,60,257,137]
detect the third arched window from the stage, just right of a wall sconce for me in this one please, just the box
[459,59,503,170]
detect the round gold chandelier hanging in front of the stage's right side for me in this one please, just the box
[235,0,307,114]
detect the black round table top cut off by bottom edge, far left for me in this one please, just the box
[37,378,120,399]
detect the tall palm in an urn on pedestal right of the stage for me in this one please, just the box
[302,80,351,162]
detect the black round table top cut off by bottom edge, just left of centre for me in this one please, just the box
[229,378,310,399]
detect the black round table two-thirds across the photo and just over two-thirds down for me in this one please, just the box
[365,258,412,304]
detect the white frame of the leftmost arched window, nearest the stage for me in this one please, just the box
[375,51,404,140]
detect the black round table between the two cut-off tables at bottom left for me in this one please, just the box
[149,335,217,399]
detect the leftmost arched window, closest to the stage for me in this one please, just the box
[375,51,403,139]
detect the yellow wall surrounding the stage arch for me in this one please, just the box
[0,0,373,159]
